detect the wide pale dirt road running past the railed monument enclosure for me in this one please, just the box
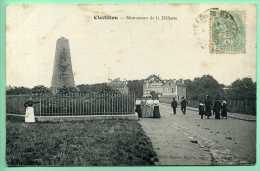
[139,104,255,165]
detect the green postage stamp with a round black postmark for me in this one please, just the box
[209,8,246,54]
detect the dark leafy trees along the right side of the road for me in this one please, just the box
[184,75,256,101]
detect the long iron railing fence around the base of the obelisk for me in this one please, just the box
[6,93,135,116]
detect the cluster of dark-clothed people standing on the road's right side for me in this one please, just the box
[199,95,227,119]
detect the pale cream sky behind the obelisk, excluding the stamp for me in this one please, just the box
[6,4,256,87]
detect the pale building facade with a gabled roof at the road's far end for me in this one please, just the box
[143,75,186,100]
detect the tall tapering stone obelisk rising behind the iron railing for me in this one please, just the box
[51,37,75,94]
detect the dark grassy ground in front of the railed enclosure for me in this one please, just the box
[6,118,157,166]
